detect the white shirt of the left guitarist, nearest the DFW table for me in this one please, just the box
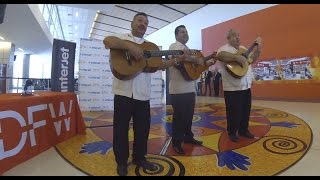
[112,33,151,101]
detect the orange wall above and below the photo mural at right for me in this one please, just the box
[202,4,320,100]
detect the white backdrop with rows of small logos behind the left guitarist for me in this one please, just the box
[79,38,163,111]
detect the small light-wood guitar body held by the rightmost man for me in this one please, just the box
[226,45,251,78]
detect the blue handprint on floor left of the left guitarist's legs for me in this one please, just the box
[80,141,112,155]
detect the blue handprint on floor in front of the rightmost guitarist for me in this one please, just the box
[217,151,251,171]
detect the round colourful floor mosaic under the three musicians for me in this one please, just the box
[56,104,312,176]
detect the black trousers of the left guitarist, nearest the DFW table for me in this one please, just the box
[113,95,150,165]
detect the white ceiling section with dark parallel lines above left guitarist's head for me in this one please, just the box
[90,4,206,40]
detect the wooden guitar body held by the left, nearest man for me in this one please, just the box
[110,41,162,80]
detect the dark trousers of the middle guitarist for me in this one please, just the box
[170,92,195,146]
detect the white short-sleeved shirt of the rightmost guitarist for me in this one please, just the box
[217,44,252,91]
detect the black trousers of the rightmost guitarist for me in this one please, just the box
[224,89,251,135]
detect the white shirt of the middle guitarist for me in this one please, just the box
[169,41,196,94]
